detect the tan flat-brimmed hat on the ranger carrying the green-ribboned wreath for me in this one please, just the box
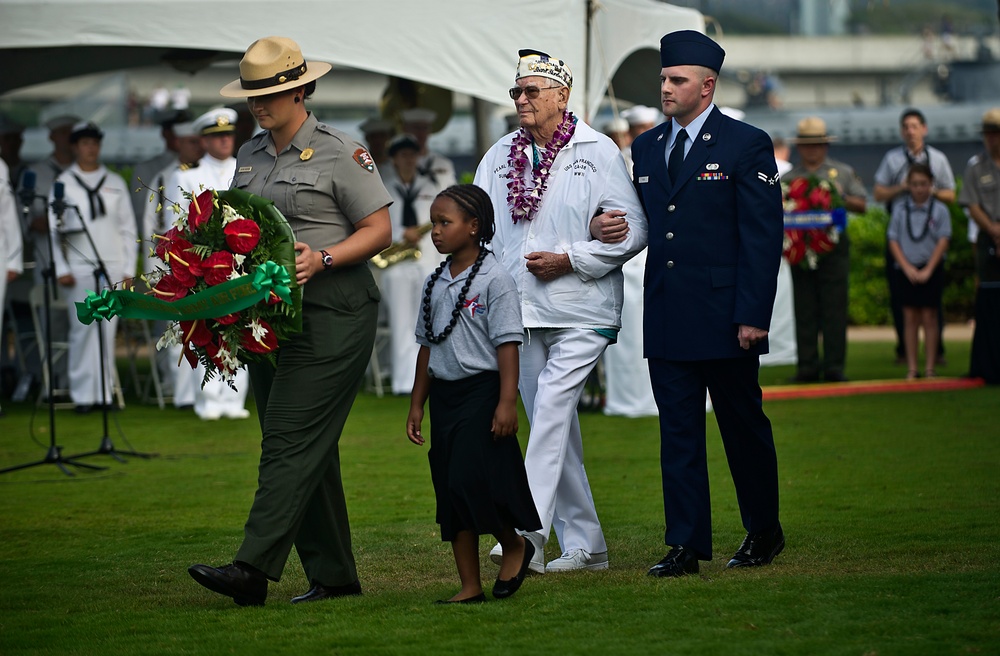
[219,36,333,98]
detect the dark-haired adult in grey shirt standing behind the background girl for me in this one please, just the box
[872,107,955,361]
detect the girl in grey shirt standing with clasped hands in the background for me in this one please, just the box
[888,164,951,380]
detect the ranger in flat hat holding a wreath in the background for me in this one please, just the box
[781,116,867,383]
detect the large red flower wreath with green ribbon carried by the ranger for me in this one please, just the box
[76,189,302,385]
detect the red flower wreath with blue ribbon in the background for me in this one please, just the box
[781,169,847,269]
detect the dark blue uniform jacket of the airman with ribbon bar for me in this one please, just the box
[632,107,784,360]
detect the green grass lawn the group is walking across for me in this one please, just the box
[0,342,1000,656]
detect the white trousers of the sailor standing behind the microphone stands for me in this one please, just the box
[60,268,118,405]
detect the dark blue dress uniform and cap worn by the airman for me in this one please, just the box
[632,31,784,576]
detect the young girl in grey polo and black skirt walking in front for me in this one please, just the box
[406,184,541,603]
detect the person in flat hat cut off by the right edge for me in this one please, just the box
[958,107,1000,385]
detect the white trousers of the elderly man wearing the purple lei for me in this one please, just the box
[519,328,608,553]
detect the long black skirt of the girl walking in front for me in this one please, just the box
[427,371,542,542]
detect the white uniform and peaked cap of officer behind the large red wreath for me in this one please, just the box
[164,107,250,420]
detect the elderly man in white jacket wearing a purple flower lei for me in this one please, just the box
[475,50,646,573]
